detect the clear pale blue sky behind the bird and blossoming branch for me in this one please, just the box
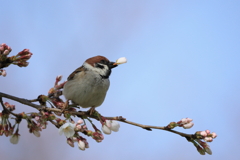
[0,0,240,160]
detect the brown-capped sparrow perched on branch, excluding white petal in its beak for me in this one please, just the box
[63,56,118,113]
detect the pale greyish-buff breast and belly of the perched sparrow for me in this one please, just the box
[63,73,110,108]
